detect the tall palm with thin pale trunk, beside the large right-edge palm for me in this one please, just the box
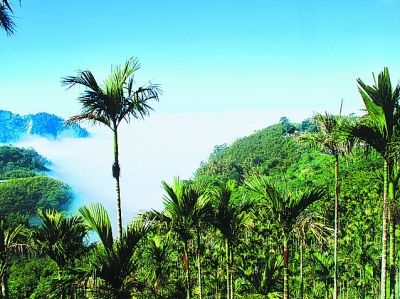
[299,113,354,299]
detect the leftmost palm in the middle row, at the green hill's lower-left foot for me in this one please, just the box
[152,178,210,299]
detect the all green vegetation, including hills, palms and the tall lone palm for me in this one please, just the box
[0,66,400,299]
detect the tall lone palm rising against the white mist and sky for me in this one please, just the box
[61,57,160,237]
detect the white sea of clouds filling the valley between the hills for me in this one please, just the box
[10,109,312,230]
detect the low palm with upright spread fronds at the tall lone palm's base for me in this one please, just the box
[75,204,151,298]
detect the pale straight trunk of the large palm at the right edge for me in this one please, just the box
[381,160,389,299]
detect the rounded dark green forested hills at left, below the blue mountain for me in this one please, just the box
[0,146,72,224]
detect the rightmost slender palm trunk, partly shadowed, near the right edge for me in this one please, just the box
[388,180,396,299]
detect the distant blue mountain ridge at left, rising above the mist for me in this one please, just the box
[0,110,89,143]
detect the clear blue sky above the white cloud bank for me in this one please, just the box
[0,0,400,117]
